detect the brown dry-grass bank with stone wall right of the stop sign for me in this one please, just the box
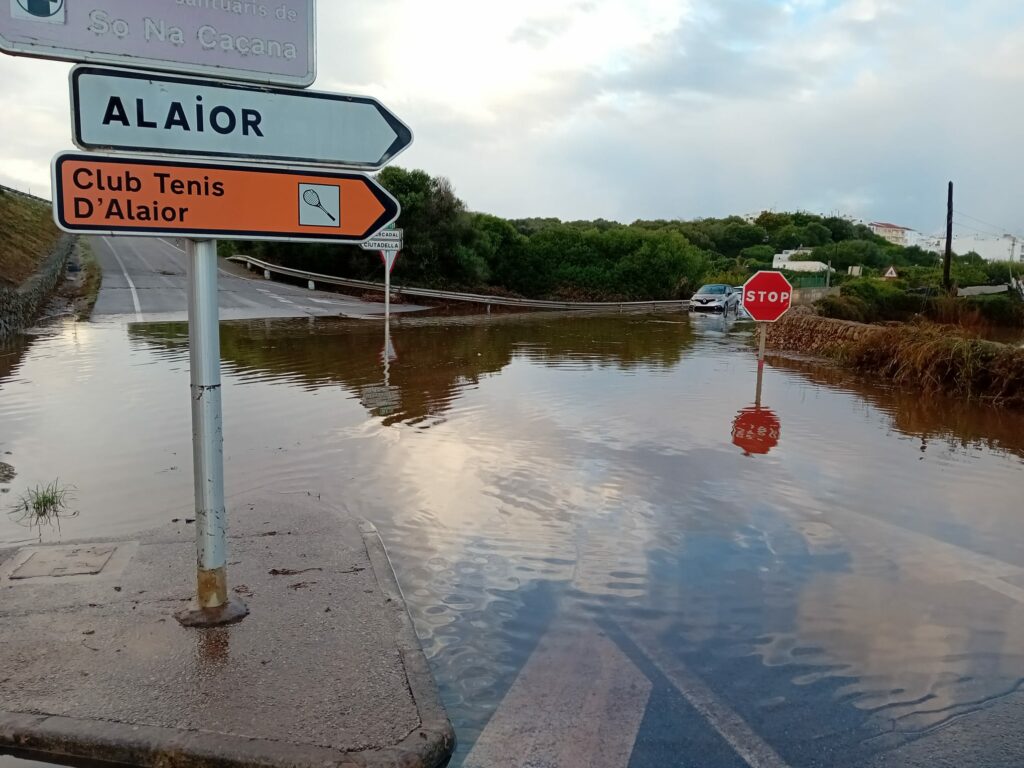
[768,314,1024,408]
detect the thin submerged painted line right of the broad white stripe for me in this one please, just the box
[624,628,788,768]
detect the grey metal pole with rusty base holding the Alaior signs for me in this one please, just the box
[177,240,249,627]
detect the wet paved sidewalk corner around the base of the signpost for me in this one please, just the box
[0,494,454,768]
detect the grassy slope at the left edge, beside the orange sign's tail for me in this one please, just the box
[0,187,60,287]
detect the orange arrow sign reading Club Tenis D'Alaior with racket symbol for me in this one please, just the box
[53,153,399,243]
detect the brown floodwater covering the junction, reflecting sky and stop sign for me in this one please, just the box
[0,314,1024,768]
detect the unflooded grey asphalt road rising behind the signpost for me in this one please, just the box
[89,237,407,323]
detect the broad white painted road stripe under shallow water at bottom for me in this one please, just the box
[464,622,651,768]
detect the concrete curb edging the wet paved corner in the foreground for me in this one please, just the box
[0,522,455,768]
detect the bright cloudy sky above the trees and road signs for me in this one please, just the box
[0,0,1024,233]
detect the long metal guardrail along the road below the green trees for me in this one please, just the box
[228,256,690,311]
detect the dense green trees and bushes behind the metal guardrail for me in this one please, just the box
[230,166,1024,319]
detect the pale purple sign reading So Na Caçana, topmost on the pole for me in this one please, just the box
[0,0,316,87]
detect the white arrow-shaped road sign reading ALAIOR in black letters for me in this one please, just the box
[71,67,413,170]
